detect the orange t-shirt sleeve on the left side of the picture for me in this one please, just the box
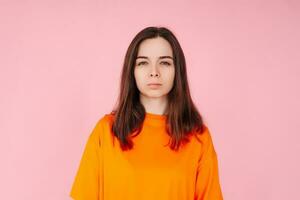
[69,122,101,200]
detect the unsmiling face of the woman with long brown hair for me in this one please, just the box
[134,37,175,98]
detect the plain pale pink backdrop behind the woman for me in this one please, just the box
[0,0,300,200]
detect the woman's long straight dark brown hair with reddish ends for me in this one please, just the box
[111,27,204,150]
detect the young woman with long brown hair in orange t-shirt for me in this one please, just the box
[70,27,223,200]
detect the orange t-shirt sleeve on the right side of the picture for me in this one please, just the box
[194,127,223,200]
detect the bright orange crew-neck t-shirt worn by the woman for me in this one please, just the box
[70,113,223,200]
